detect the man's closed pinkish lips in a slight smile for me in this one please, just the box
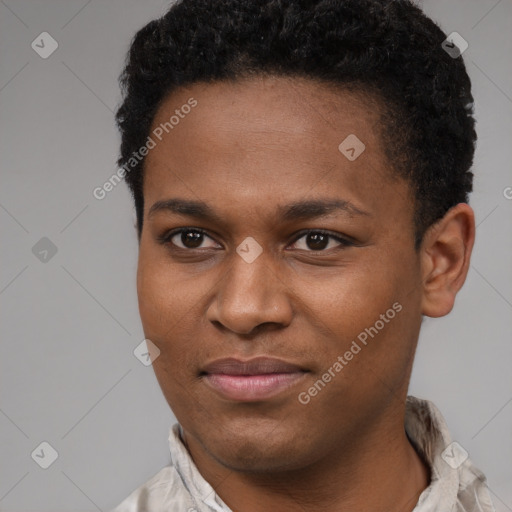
[200,357,307,402]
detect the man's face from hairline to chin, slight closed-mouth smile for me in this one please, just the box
[137,78,421,471]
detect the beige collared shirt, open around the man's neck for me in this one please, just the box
[111,396,495,512]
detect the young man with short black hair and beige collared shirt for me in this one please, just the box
[110,0,494,512]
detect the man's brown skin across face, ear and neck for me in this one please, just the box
[137,77,474,512]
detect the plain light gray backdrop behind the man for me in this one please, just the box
[0,0,512,512]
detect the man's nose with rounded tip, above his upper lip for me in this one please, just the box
[207,249,293,335]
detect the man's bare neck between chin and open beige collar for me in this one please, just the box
[185,408,430,512]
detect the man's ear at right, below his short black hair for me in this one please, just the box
[420,203,475,317]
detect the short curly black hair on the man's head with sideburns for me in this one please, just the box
[116,0,476,248]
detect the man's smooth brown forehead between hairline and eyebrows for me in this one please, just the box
[144,77,410,226]
